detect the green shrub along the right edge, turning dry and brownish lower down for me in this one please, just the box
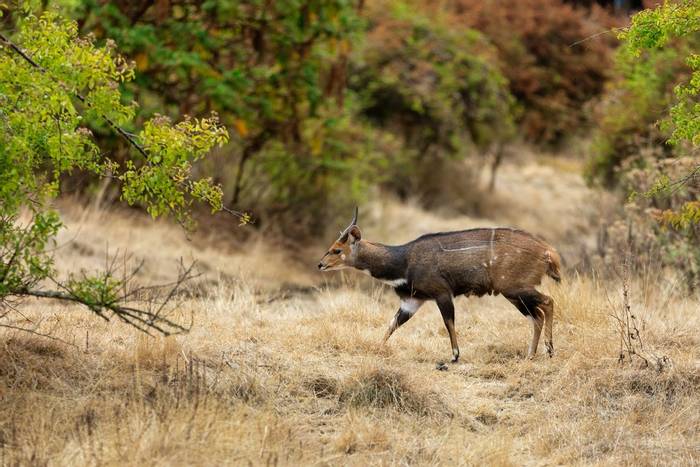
[588,0,700,290]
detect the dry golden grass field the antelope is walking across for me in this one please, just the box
[0,159,700,465]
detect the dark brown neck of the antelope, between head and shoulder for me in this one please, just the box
[355,240,407,281]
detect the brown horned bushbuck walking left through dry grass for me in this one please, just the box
[318,208,561,362]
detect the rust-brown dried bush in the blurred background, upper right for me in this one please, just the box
[434,0,620,143]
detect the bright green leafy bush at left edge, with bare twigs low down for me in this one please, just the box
[0,9,243,335]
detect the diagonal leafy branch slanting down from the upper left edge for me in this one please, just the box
[0,13,250,225]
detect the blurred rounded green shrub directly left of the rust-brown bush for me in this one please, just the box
[349,1,514,204]
